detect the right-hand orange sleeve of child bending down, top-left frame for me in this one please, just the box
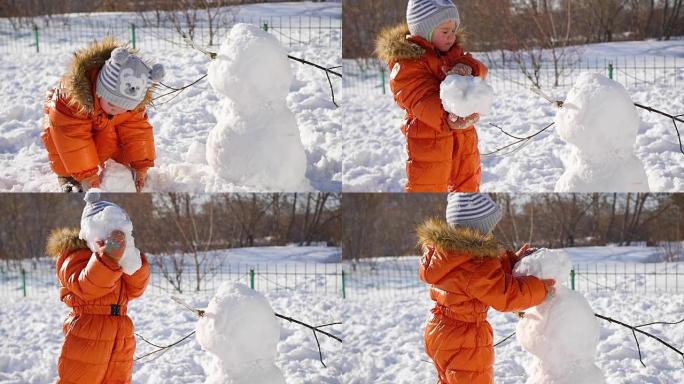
[117,110,156,169]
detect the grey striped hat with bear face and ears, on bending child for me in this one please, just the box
[96,47,164,110]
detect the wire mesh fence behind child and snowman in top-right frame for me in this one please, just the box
[343,56,684,95]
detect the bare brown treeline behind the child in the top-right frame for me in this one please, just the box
[342,0,684,58]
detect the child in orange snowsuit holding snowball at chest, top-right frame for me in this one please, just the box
[377,0,487,192]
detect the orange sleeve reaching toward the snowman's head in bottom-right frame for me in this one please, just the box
[466,259,546,312]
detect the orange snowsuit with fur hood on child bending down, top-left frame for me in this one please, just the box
[41,38,155,181]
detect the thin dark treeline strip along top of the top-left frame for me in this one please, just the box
[0,0,325,17]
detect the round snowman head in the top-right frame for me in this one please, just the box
[555,73,639,157]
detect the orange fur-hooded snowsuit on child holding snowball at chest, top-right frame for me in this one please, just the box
[377,24,488,192]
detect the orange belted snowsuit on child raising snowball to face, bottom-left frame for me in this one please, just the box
[48,229,150,384]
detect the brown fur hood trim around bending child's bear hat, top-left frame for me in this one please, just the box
[61,36,156,114]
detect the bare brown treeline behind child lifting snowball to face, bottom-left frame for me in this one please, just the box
[0,193,342,263]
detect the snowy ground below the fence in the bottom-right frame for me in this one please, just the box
[341,292,684,384]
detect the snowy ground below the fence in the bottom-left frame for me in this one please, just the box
[0,291,346,384]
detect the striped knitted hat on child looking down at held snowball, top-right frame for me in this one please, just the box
[406,0,461,41]
